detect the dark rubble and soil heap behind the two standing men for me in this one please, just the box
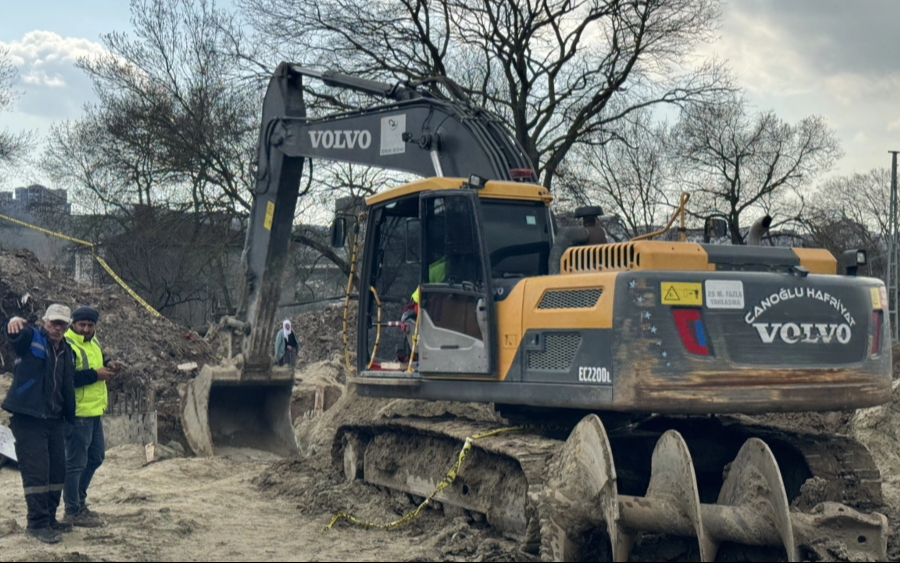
[0,248,215,444]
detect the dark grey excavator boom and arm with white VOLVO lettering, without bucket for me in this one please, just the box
[238,63,535,373]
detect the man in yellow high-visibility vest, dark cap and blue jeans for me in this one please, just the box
[63,307,125,528]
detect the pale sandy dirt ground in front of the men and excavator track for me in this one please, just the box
[0,362,517,561]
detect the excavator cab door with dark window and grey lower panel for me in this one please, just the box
[417,189,495,377]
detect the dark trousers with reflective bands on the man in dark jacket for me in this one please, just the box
[9,414,66,529]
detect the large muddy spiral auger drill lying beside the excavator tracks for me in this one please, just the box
[537,415,888,561]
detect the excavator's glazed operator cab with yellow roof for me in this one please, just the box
[357,183,552,378]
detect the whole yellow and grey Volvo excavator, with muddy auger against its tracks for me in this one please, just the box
[184,63,892,561]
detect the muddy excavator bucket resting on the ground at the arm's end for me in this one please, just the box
[181,365,299,457]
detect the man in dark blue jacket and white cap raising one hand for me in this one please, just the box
[0,304,75,543]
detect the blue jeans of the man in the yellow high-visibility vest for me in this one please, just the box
[63,416,106,515]
